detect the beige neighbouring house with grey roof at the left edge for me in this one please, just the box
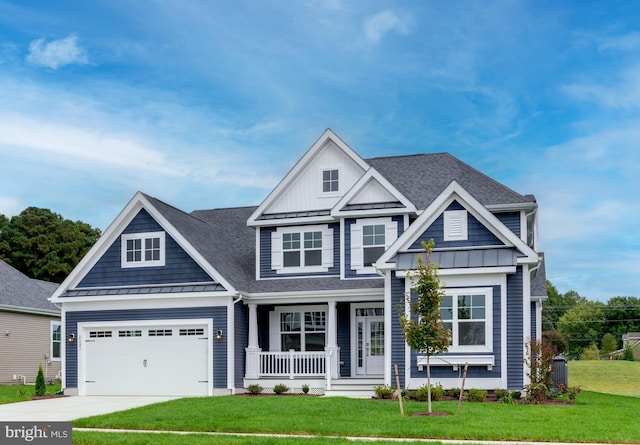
[0,260,61,384]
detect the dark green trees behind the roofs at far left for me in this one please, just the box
[0,207,100,283]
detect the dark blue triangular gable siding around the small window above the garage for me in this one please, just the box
[78,209,212,288]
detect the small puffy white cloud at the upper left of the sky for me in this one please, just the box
[27,34,89,70]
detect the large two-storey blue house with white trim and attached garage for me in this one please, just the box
[51,130,546,395]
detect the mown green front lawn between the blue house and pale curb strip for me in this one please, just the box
[74,391,640,443]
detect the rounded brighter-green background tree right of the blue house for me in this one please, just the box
[558,300,606,359]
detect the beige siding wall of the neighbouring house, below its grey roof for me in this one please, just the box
[0,311,60,384]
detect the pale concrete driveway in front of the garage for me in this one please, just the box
[0,396,178,422]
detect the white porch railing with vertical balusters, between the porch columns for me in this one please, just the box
[259,349,330,379]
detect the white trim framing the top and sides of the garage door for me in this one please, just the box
[76,318,214,396]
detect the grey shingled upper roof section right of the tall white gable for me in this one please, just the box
[365,153,535,209]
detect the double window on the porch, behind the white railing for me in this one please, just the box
[269,306,327,351]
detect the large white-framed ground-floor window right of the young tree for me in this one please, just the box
[440,288,493,352]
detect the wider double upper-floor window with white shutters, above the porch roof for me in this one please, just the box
[271,225,333,273]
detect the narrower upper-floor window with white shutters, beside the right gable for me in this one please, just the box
[351,217,398,274]
